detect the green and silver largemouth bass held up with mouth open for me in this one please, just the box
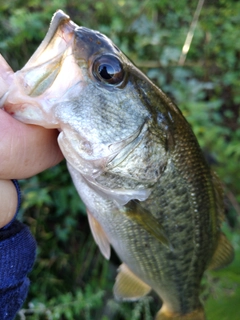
[0,10,234,320]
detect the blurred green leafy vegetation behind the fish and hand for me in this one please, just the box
[0,0,240,320]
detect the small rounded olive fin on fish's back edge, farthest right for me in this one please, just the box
[208,232,234,270]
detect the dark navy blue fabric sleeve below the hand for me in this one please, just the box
[0,180,36,320]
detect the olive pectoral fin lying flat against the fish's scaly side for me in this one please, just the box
[125,201,173,250]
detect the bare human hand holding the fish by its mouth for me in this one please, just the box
[0,59,63,228]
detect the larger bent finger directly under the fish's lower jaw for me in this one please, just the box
[0,110,63,179]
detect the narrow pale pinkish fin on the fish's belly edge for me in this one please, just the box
[87,210,111,260]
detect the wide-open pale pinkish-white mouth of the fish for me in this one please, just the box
[0,10,83,128]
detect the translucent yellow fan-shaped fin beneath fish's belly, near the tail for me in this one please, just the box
[113,263,151,301]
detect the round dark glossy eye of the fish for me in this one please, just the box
[92,55,125,85]
